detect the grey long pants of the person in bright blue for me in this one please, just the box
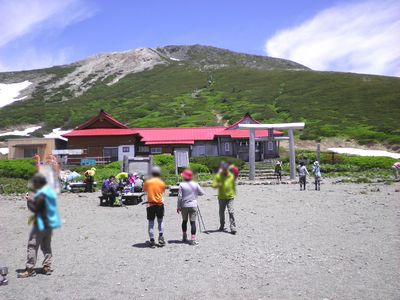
[26,226,53,269]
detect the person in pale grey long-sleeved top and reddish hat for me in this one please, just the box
[176,170,204,245]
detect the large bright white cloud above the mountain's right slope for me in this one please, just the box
[265,0,400,76]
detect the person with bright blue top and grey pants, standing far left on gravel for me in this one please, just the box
[18,173,61,278]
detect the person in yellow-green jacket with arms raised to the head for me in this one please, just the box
[212,163,236,234]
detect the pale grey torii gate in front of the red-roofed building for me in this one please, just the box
[239,123,305,180]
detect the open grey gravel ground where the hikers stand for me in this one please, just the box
[0,184,400,299]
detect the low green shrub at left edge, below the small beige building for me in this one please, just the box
[0,160,36,179]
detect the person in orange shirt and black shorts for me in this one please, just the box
[143,166,166,248]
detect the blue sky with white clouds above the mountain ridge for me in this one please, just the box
[0,0,400,76]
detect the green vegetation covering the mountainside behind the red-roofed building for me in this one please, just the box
[0,46,400,145]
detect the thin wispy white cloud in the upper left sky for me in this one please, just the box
[0,0,94,71]
